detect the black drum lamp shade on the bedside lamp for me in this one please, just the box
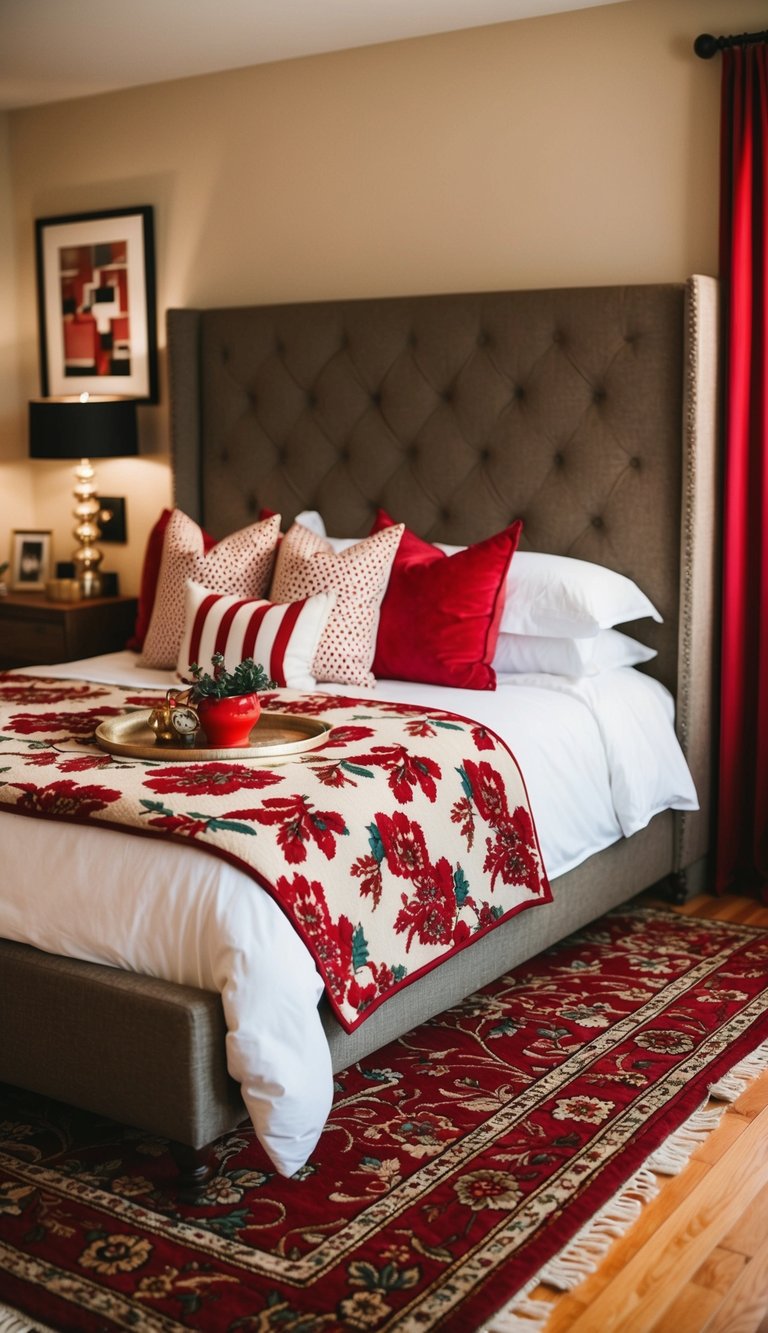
[29,395,139,459]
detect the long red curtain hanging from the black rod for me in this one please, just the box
[716,41,768,896]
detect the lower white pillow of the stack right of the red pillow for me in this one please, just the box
[492,629,656,676]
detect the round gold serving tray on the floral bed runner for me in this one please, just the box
[96,708,331,764]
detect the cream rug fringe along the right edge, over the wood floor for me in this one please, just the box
[482,1041,768,1333]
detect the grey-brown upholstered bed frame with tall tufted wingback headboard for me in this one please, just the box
[0,277,717,1182]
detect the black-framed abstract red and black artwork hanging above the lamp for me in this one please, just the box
[35,204,157,403]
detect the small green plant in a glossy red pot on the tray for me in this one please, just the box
[189,653,275,748]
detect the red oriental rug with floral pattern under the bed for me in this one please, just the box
[0,908,768,1333]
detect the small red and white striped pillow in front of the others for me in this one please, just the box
[176,579,336,690]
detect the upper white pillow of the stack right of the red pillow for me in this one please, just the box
[501,551,661,639]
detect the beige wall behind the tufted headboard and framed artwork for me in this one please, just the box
[0,0,765,589]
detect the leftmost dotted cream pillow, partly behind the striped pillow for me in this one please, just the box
[139,509,280,670]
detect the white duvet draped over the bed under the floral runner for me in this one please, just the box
[0,652,697,1176]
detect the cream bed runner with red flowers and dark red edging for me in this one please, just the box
[0,673,551,1032]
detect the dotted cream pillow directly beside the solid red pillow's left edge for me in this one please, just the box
[269,523,403,686]
